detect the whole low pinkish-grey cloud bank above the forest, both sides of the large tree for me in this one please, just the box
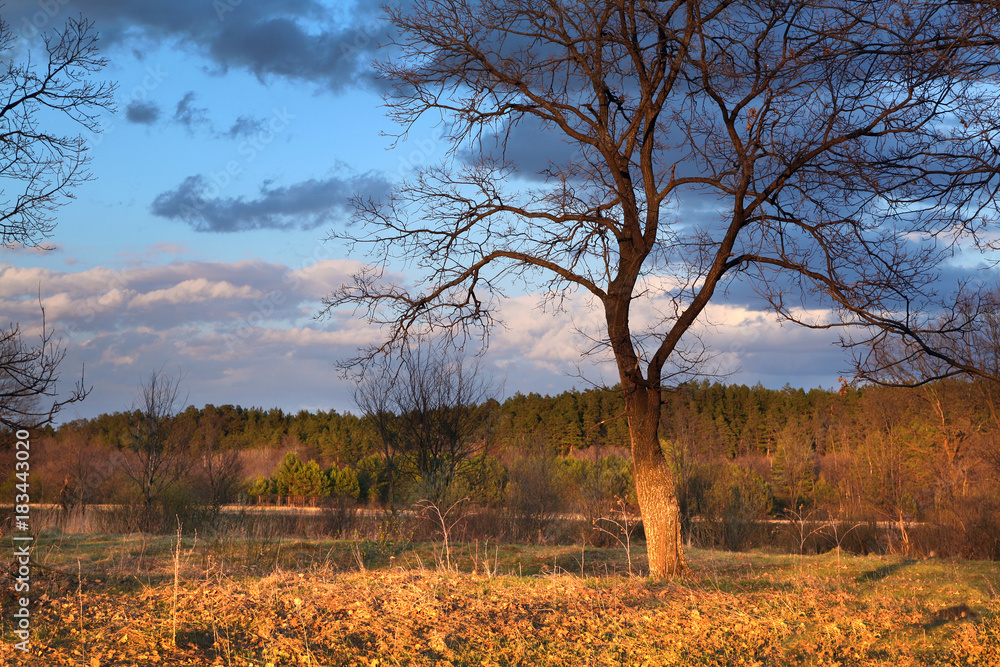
[0,250,844,419]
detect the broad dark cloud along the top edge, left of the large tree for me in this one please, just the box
[4,0,390,91]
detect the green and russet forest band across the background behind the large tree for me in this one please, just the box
[4,380,1000,559]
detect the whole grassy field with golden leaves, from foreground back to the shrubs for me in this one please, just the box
[0,536,1000,667]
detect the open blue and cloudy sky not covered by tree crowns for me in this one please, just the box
[0,0,860,421]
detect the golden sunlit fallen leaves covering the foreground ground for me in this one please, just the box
[0,570,1000,667]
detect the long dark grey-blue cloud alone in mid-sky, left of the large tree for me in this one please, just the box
[152,173,389,232]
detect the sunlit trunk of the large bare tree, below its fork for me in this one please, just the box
[625,388,685,578]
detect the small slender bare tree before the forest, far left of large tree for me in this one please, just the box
[119,371,190,529]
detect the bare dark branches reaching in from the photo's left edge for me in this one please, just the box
[0,19,115,428]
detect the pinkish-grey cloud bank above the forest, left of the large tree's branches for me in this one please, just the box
[0,258,377,419]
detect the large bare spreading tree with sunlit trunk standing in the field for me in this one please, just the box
[324,0,1000,576]
